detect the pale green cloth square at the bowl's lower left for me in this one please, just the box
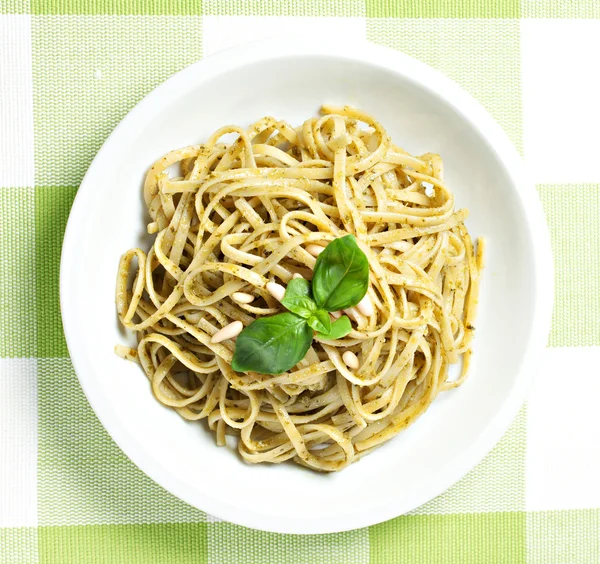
[38,358,206,526]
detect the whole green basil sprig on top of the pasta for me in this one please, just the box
[231,235,369,374]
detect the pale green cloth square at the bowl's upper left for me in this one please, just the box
[32,16,202,186]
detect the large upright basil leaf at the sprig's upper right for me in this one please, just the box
[312,235,369,311]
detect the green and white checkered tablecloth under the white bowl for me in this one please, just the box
[0,0,600,564]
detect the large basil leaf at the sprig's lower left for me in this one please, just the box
[231,312,313,374]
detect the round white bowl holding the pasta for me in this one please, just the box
[60,41,552,533]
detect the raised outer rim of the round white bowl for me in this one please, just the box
[60,39,554,534]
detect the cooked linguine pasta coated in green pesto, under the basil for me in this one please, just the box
[115,106,483,471]
